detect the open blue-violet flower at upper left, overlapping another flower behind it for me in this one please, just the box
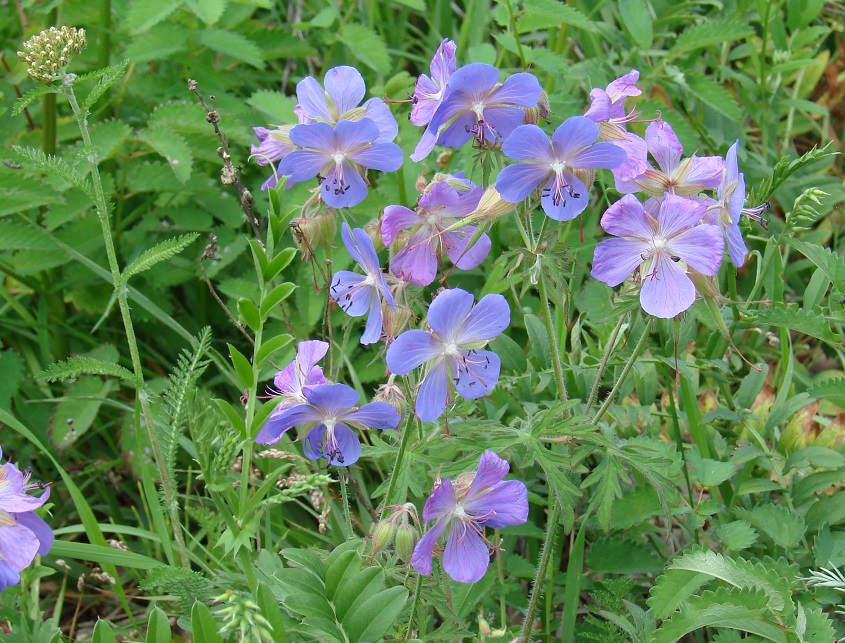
[278,118,402,208]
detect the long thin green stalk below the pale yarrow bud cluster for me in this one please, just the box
[62,77,190,568]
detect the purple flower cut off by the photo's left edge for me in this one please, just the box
[0,451,53,590]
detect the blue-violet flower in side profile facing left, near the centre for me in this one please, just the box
[329,223,396,344]
